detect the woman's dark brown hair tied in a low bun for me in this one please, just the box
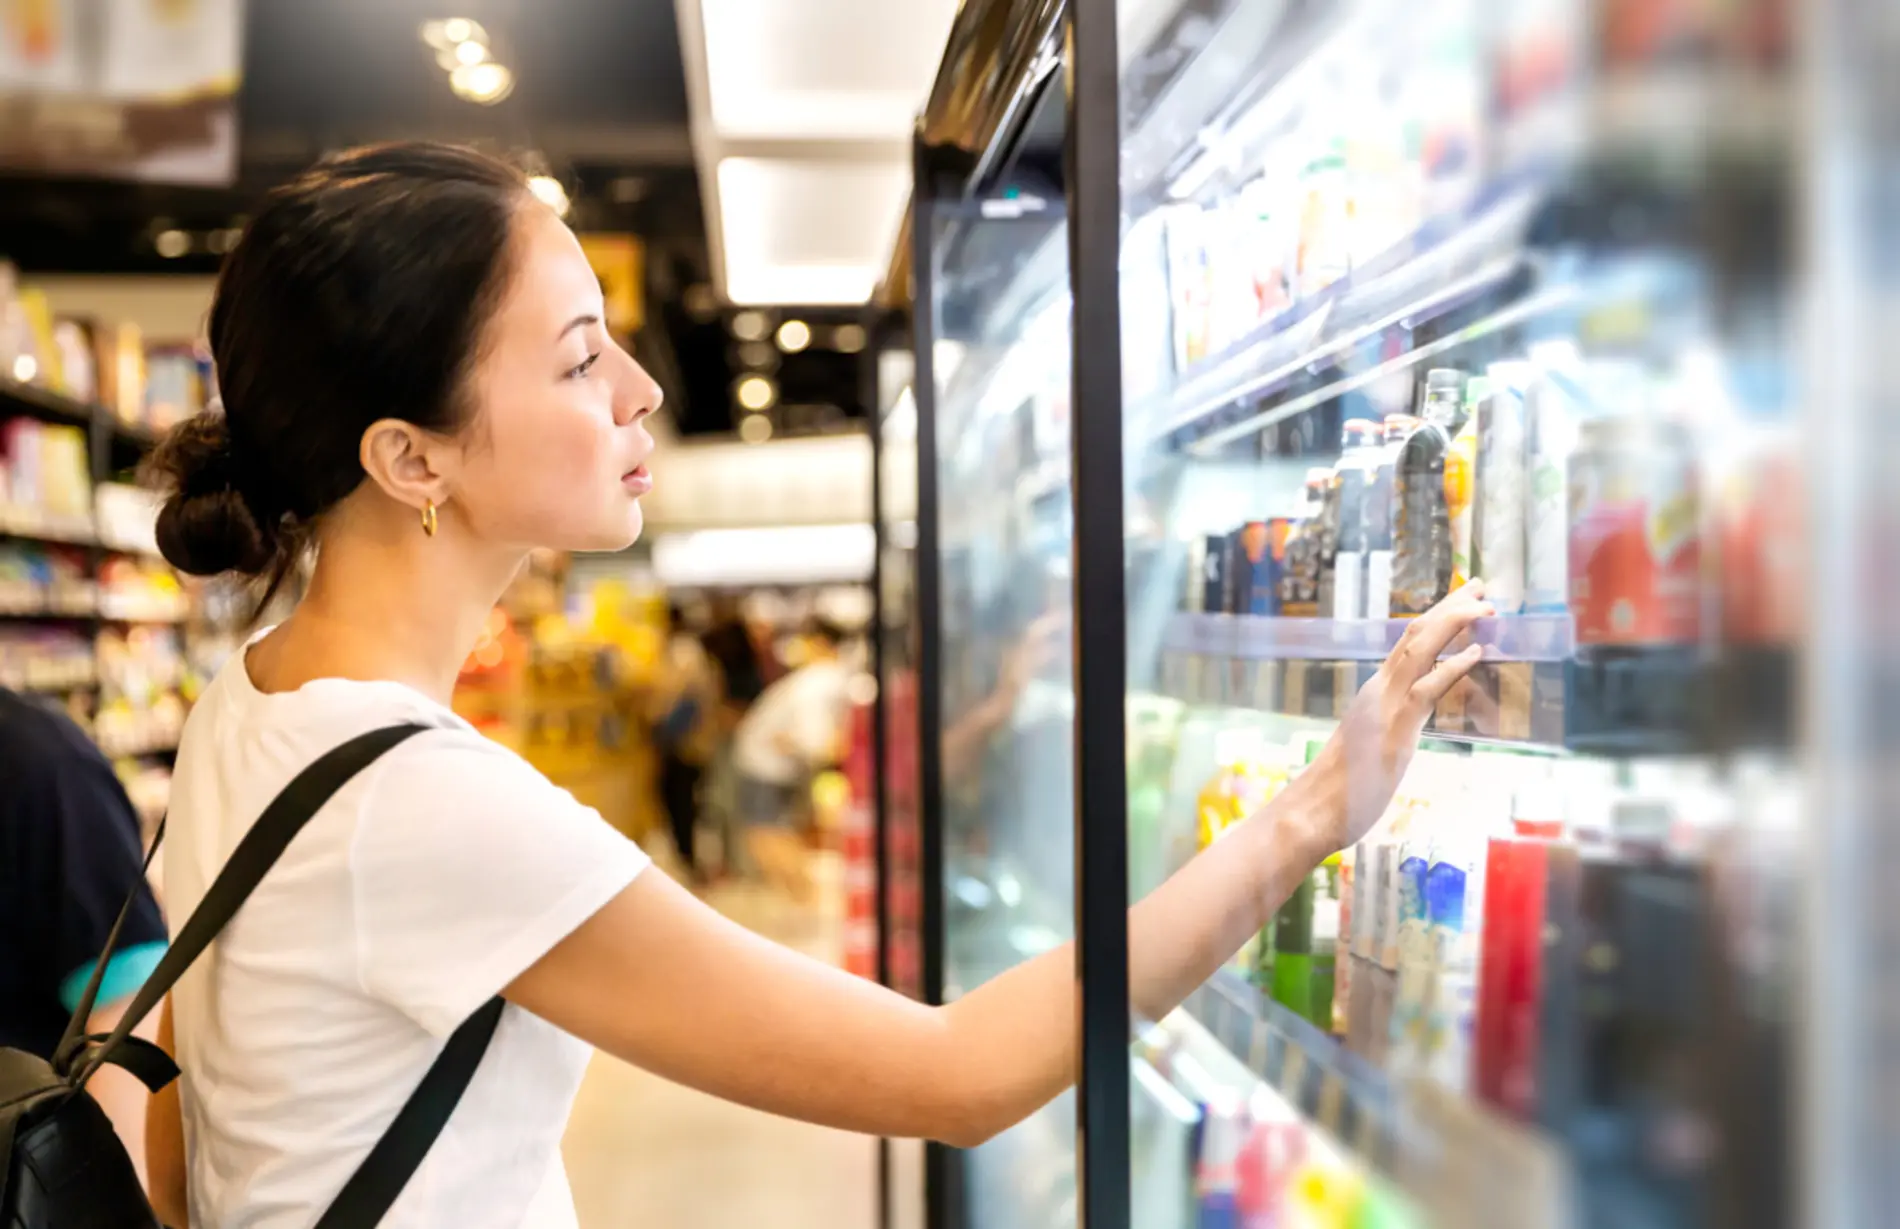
[146,142,526,600]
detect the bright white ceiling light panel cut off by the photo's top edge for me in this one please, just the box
[699,0,958,141]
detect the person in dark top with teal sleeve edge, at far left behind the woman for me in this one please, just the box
[0,688,165,1178]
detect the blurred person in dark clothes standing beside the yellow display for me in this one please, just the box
[648,602,724,883]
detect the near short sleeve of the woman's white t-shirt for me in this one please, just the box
[352,731,648,1037]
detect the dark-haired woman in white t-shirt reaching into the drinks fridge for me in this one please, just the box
[150,144,1486,1229]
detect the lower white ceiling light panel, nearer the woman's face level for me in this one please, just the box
[718,158,910,306]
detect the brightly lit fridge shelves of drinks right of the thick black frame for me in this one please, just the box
[1081,0,1807,1229]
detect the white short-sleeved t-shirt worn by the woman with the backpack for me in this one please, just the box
[165,653,648,1229]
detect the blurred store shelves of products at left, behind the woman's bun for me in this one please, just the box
[0,260,248,839]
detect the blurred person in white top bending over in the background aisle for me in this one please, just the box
[732,619,851,900]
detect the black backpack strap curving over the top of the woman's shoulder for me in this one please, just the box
[68,724,431,1088]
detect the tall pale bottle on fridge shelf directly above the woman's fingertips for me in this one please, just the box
[1471,361,1537,615]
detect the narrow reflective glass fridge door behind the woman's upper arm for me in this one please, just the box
[918,198,1075,1229]
